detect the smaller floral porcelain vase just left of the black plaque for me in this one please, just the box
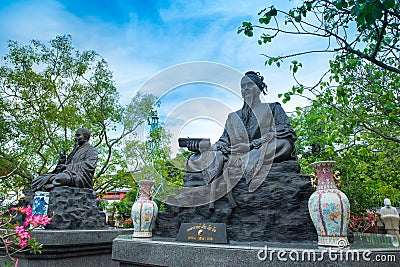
[131,180,158,238]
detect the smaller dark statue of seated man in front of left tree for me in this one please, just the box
[32,128,98,191]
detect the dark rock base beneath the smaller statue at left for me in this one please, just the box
[25,186,107,230]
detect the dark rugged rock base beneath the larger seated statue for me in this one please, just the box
[154,161,317,242]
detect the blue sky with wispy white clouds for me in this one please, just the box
[0,0,328,153]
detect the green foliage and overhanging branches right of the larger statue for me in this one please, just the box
[238,0,400,212]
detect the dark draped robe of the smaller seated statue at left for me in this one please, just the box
[32,143,98,191]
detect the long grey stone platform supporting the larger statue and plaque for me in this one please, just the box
[112,234,400,267]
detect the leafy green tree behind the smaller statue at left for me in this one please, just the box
[0,35,154,195]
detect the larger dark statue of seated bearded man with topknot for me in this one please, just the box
[167,71,297,209]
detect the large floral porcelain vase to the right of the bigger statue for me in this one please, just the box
[308,161,350,248]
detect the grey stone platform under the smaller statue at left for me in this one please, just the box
[16,229,133,267]
